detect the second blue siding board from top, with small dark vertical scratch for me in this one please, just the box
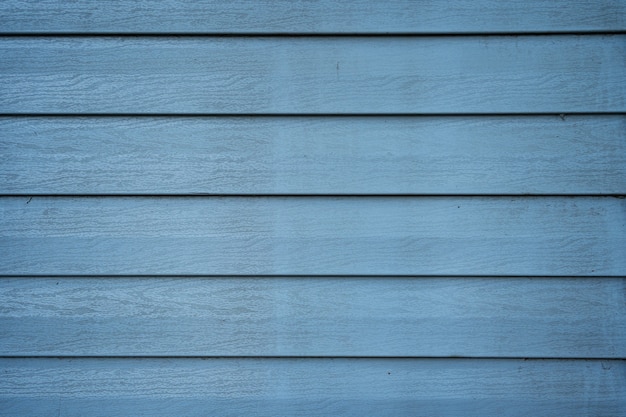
[0,35,626,114]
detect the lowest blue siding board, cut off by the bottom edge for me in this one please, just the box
[0,358,626,417]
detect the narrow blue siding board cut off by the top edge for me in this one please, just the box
[0,0,626,34]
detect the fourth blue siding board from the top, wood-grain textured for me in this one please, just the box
[0,197,626,276]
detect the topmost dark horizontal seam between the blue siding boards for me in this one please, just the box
[0,29,626,38]
